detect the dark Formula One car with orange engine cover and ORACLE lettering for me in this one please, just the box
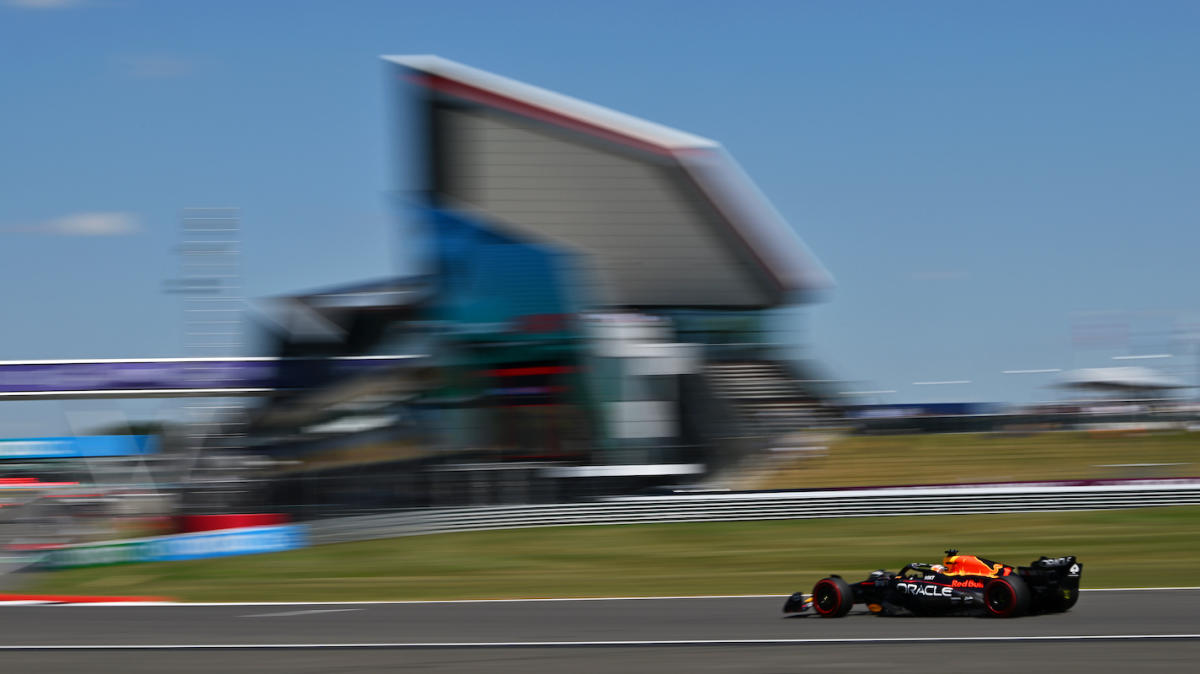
[784,550,1084,618]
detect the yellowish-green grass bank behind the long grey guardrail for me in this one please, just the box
[749,432,1200,489]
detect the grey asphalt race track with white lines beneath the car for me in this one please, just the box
[0,589,1200,674]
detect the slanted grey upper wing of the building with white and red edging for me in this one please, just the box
[384,55,832,308]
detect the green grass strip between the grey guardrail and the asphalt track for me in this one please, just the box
[26,507,1200,601]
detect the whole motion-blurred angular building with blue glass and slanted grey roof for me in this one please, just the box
[231,56,830,510]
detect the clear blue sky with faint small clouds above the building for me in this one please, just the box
[0,0,1200,432]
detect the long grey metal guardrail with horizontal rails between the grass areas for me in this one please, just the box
[308,482,1200,544]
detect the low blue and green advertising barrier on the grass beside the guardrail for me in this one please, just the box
[40,524,307,568]
